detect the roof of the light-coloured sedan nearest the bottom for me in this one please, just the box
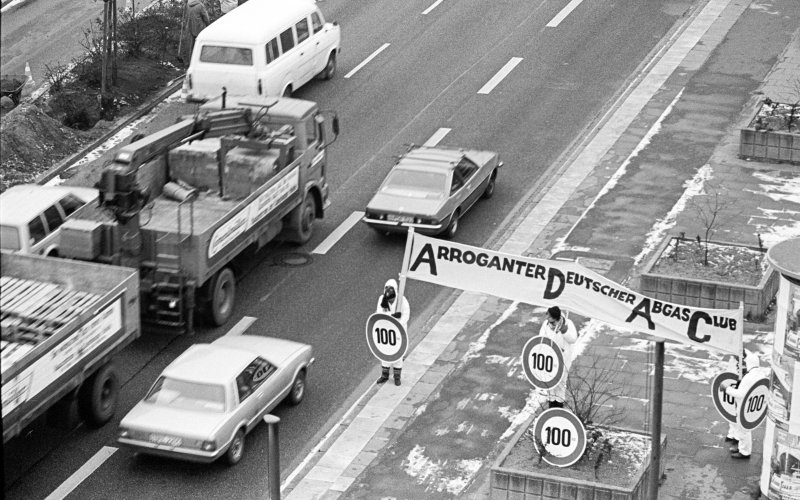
[162,344,256,384]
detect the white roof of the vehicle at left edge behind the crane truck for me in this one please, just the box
[0,184,98,225]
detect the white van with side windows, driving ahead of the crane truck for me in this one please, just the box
[184,0,341,101]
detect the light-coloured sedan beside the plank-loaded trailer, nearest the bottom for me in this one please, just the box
[117,335,314,465]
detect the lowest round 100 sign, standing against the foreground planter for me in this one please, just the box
[533,408,586,467]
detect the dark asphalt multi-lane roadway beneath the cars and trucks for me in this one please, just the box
[3,0,704,499]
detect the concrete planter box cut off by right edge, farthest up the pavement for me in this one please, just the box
[739,102,800,165]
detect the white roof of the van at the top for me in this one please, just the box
[197,0,316,46]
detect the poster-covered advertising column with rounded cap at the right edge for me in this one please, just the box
[760,238,800,500]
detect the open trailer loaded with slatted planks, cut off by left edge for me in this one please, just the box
[0,251,140,442]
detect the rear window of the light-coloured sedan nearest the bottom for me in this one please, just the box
[144,377,225,413]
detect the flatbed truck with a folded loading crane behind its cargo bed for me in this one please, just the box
[59,96,338,333]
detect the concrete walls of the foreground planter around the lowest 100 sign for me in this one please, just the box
[489,417,667,500]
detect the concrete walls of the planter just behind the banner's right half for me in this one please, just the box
[639,236,778,320]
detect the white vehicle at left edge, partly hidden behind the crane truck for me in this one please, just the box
[0,184,100,256]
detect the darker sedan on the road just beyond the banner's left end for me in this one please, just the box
[362,146,503,238]
